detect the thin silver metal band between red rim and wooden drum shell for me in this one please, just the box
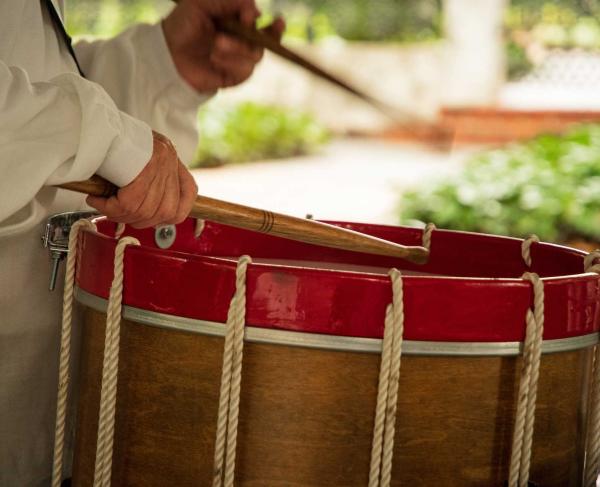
[75,287,600,356]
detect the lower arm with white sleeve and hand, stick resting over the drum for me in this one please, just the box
[0,61,197,227]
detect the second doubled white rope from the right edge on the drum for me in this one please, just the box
[508,272,544,487]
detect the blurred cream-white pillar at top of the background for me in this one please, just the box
[442,0,507,107]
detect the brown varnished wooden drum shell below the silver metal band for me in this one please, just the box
[73,219,598,487]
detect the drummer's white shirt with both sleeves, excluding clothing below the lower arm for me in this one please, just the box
[0,0,205,235]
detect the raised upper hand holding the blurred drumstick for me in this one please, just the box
[162,0,285,92]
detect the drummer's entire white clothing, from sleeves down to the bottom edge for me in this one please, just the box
[0,0,205,487]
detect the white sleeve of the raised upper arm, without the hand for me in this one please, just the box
[74,24,211,163]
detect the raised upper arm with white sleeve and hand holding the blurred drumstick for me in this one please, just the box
[75,0,284,162]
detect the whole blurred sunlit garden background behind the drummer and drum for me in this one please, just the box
[67,0,600,250]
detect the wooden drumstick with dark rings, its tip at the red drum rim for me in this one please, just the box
[58,176,429,264]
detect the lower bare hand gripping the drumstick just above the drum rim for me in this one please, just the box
[86,132,198,228]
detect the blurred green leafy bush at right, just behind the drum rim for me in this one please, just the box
[400,125,600,242]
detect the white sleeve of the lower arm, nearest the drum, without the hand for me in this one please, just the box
[0,61,152,225]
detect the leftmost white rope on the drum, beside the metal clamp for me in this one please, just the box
[52,220,96,487]
